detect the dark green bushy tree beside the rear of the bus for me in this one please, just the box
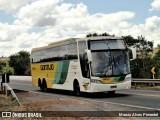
[9,51,30,75]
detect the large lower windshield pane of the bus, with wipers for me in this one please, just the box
[91,50,130,77]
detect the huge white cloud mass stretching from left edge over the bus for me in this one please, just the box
[0,0,135,54]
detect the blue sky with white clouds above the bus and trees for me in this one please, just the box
[0,0,160,57]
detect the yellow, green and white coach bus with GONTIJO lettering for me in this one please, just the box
[31,36,135,95]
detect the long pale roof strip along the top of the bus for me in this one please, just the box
[32,36,122,51]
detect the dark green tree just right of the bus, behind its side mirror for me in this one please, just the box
[123,35,154,78]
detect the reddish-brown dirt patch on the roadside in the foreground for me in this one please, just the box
[16,92,88,111]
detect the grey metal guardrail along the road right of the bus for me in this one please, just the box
[132,78,160,89]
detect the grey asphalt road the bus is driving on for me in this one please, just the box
[0,76,160,111]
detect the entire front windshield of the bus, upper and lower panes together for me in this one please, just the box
[89,39,130,77]
